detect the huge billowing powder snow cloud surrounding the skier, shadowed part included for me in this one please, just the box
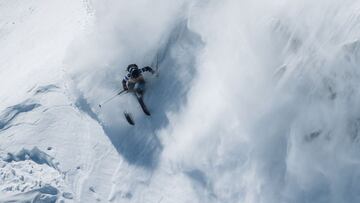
[64,0,360,202]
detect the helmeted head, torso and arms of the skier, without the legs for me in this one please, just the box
[122,64,155,95]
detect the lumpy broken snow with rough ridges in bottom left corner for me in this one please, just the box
[0,148,73,202]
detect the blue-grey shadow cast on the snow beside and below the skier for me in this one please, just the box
[77,20,203,169]
